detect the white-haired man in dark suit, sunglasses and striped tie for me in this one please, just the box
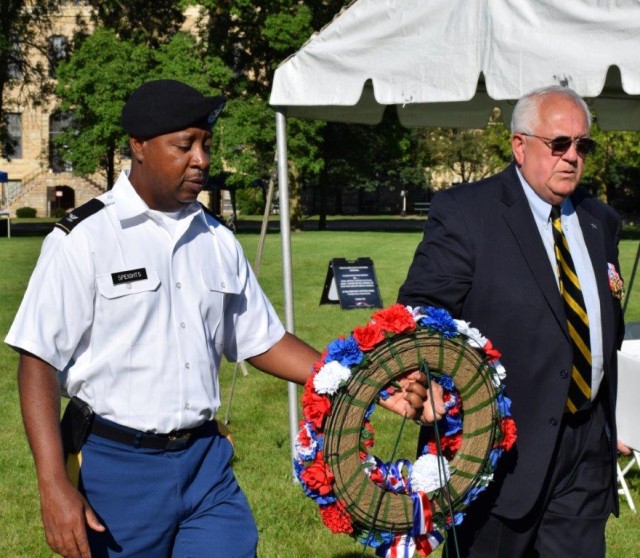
[399,86,628,558]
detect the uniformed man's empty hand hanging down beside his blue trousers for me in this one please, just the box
[40,482,105,558]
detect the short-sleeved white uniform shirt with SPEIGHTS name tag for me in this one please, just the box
[5,172,285,433]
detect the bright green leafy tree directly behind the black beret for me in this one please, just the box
[57,29,231,188]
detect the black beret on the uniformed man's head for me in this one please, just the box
[120,79,226,138]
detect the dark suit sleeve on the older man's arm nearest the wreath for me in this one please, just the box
[398,191,474,316]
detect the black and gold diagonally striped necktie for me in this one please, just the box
[551,205,591,413]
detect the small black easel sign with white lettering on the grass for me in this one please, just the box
[320,258,382,310]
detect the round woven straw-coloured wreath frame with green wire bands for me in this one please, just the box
[324,330,500,533]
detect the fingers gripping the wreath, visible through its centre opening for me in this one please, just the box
[380,371,445,424]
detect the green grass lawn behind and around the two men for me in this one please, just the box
[0,232,640,558]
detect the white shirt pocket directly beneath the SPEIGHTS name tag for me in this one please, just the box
[95,267,160,345]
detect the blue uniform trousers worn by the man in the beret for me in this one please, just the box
[73,423,258,558]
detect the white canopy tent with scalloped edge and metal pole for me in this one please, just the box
[269,0,640,466]
